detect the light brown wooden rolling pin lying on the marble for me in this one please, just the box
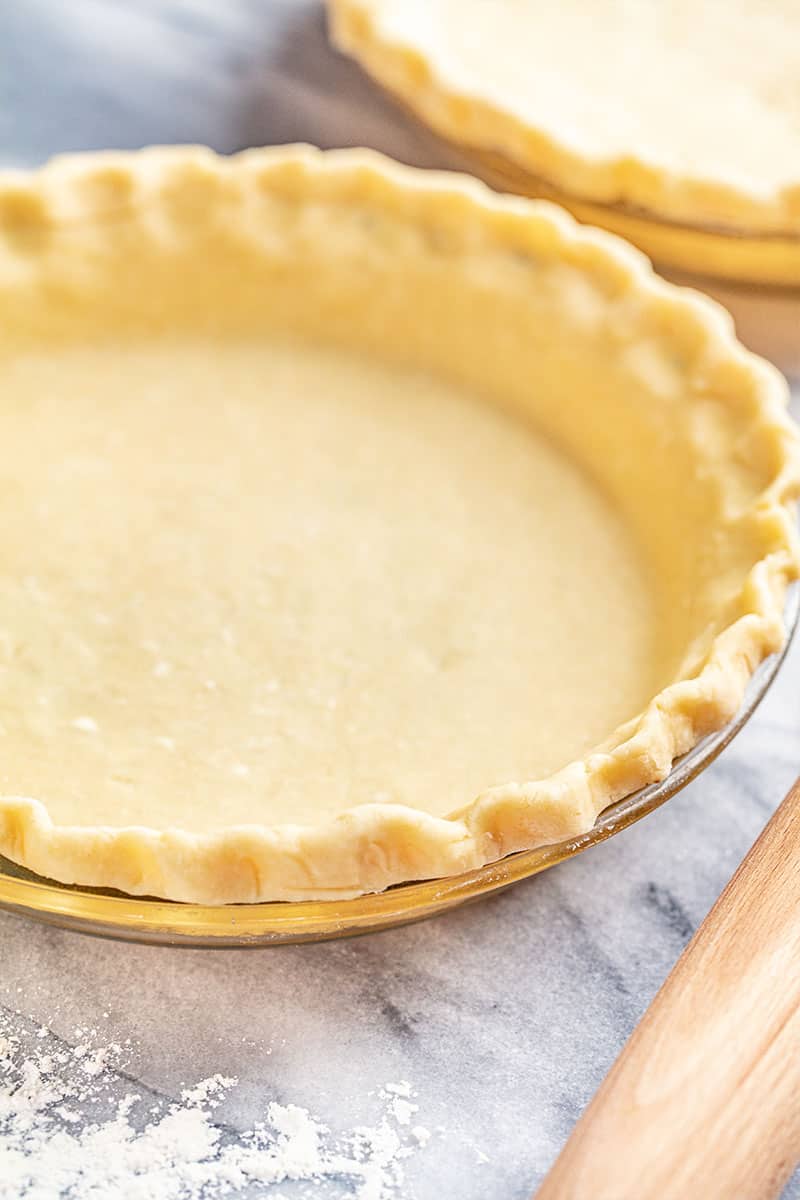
[536,780,800,1200]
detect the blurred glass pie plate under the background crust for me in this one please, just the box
[458,149,800,376]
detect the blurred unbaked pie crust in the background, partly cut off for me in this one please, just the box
[329,0,800,236]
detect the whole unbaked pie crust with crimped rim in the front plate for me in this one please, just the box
[0,148,800,904]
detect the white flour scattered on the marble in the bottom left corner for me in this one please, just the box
[0,1027,429,1200]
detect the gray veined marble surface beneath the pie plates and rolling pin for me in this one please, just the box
[0,0,800,1200]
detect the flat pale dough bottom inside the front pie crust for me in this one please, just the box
[0,337,664,832]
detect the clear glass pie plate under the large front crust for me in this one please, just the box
[0,584,800,947]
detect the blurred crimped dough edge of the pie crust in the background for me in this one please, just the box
[326,0,800,238]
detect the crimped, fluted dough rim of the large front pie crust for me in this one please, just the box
[0,146,800,905]
